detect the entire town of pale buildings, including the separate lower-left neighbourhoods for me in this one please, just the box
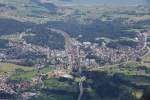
[0,28,150,99]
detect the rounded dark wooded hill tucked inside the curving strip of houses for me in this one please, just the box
[25,28,65,49]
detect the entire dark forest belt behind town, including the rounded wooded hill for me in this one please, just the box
[0,19,150,49]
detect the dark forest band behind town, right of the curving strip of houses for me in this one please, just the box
[45,20,137,42]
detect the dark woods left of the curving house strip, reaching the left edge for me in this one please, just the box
[0,19,65,49]
